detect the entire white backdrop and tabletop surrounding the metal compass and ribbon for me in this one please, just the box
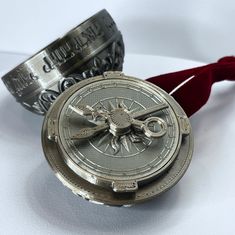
[0,0,235,235]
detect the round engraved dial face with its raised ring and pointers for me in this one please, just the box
[59,74,181,193]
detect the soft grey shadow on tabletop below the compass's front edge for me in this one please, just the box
[25,162,183,233]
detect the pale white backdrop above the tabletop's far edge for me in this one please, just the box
[0,0,235,62]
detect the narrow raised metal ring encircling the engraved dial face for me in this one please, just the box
[56,76,182,187]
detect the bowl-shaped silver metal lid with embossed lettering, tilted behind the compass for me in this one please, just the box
[2,10,124,114]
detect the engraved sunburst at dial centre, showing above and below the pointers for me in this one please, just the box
[89,97,152,157]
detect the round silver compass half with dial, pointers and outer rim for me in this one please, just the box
[42,72,193,205]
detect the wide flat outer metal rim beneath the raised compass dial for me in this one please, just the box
[42,73,193,206]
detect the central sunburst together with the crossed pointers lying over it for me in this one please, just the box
[70,97,168,157]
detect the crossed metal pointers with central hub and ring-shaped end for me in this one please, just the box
[70,101,168,139]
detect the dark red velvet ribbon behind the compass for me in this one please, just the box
[147,56,235,117]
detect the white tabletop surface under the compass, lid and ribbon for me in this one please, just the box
[0,54,235,235]
